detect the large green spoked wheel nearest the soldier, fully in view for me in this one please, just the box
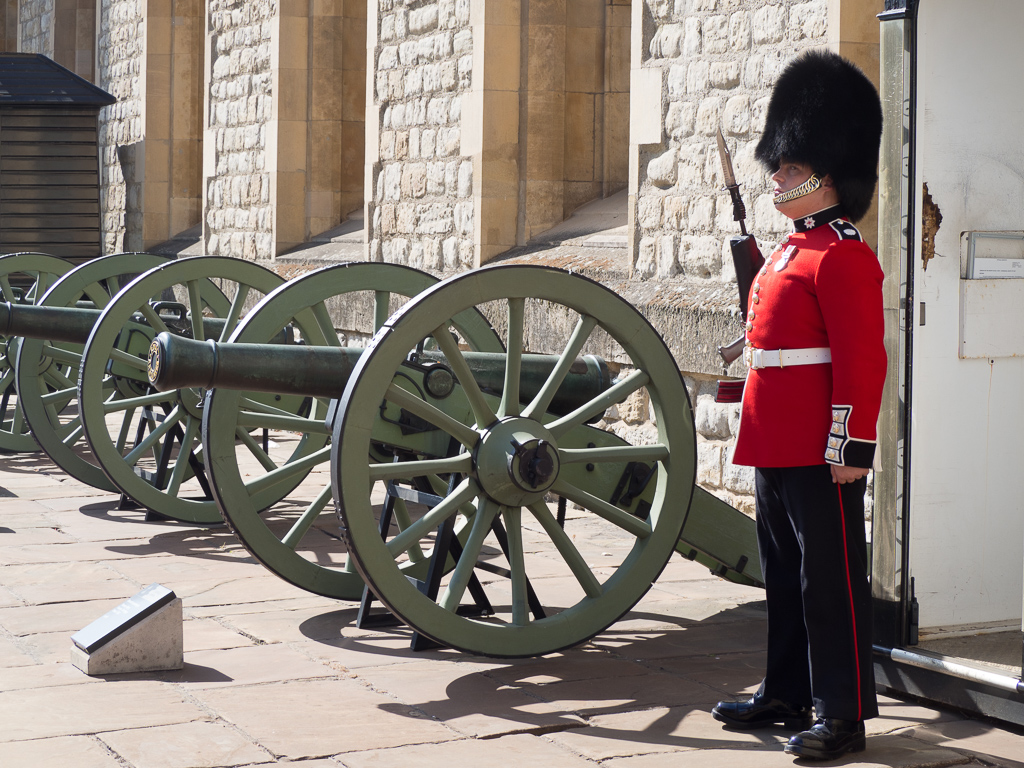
[331,266,696,657]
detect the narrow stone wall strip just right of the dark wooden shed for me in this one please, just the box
[97,0,145,253]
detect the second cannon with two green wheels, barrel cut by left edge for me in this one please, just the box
[0,254,304,523]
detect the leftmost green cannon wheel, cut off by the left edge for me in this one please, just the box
[0,253,74,454]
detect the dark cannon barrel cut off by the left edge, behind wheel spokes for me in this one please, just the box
[0,301,293,344]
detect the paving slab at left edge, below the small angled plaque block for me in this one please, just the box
[0,680,206,741]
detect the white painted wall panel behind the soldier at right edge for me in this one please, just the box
[910,0,1024,629]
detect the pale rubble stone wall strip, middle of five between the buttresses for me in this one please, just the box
[203,0,278,259]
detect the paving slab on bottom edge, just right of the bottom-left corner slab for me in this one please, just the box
[99,722,273,768]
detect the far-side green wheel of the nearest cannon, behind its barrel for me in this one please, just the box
[203,262,504,600]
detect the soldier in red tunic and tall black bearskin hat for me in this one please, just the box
[712,51,886,759]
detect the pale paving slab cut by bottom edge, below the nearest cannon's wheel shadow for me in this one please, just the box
[337,734,593,768]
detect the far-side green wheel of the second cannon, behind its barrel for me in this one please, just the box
[16,253,168,490]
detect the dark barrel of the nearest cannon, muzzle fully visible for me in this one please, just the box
[148,333,611,414]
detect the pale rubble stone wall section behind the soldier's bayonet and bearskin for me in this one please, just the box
[634,0,828,282]
